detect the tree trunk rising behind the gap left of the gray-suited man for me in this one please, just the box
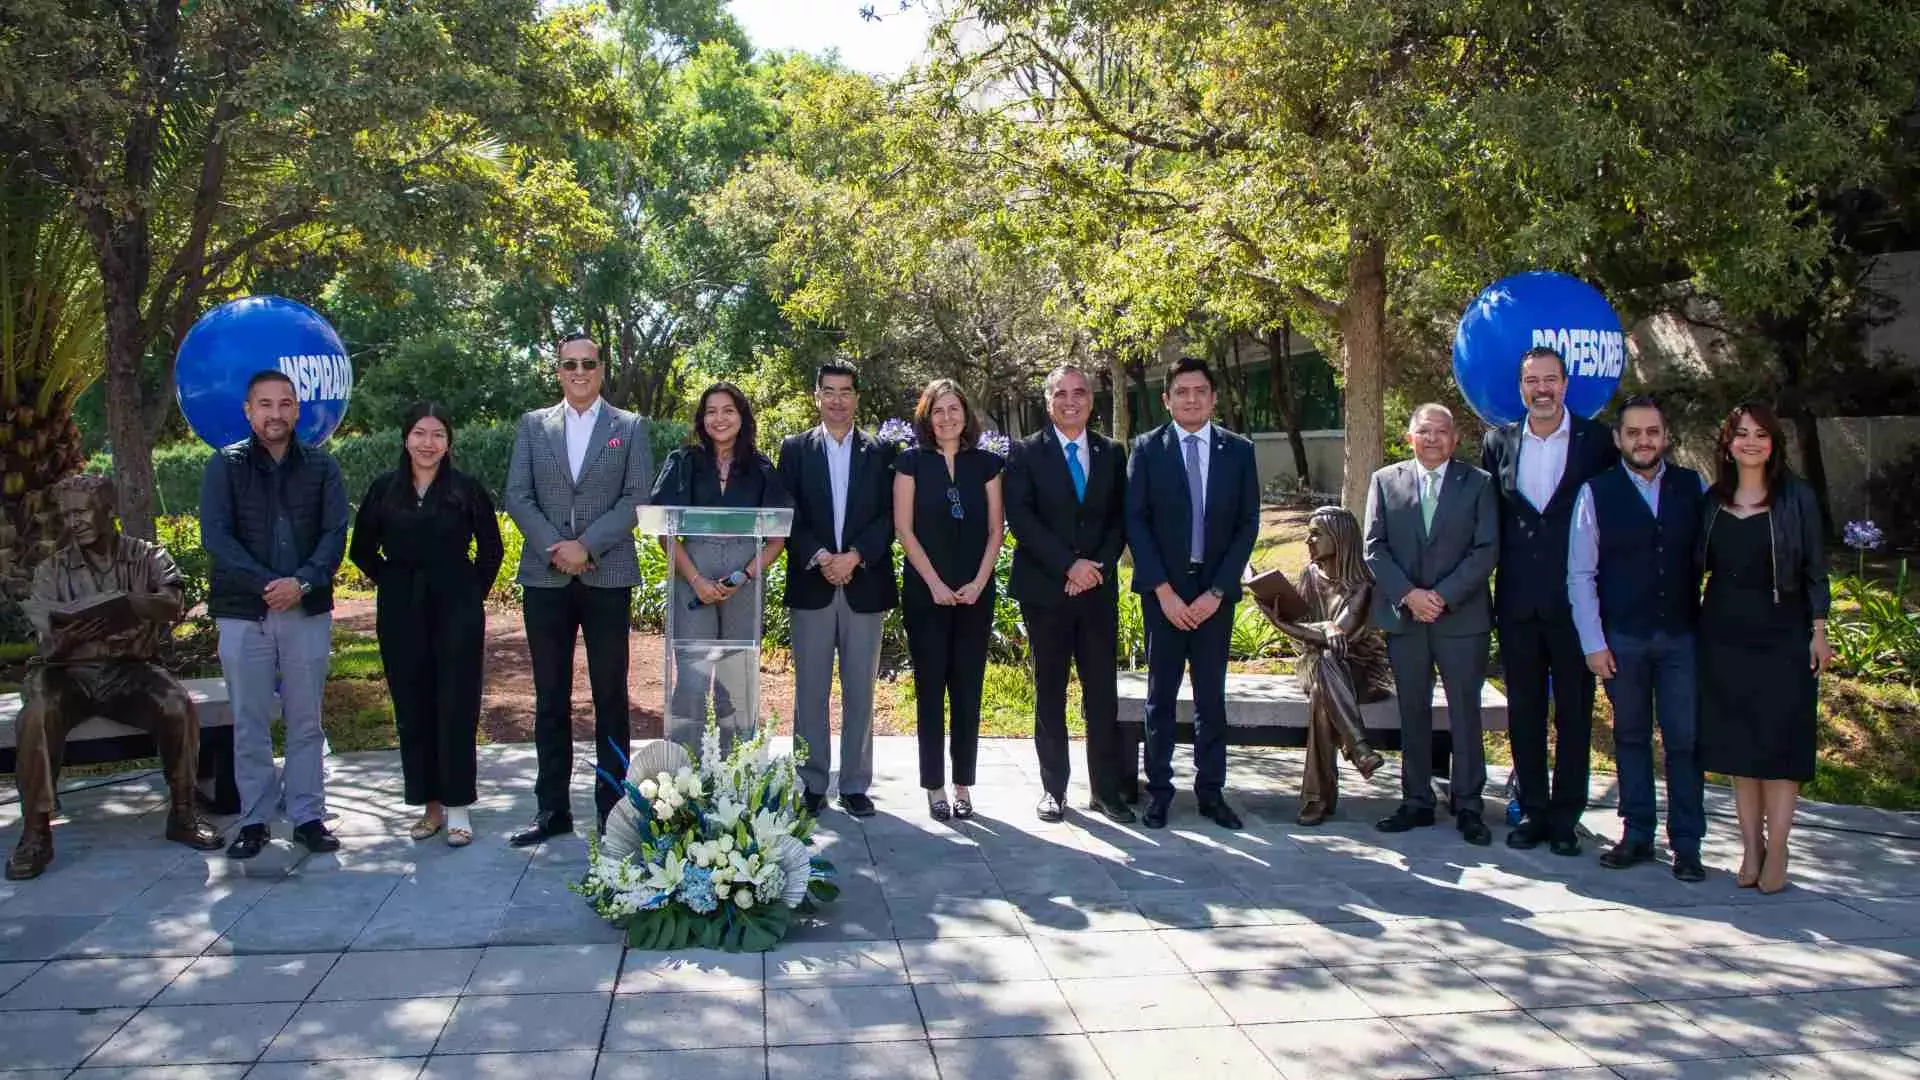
[1340,231,1386,513]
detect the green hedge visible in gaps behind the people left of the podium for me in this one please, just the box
[86,421,687,515]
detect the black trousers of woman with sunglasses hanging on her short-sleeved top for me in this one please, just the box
[900,590,995,788]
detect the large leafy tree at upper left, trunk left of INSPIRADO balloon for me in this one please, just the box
[0,0,618,536]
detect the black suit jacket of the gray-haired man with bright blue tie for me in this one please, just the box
[1006,425,1127,607]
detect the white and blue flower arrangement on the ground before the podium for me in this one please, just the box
[574,724,839,951]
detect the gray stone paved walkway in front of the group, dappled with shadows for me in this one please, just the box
[0,740,1920,1080]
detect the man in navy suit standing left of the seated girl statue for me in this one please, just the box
[1127,357,1260,828]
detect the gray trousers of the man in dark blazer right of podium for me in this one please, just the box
[793,588,887,796]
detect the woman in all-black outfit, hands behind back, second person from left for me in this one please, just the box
[348,404,501,847]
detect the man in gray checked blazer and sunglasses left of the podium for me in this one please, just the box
[507,334,653,847]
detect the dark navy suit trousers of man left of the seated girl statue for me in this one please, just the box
[1140,571,1235,803]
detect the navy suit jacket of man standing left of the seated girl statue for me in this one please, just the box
[1127,421,1259,601]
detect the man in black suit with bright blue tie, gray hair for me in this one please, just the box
[1006,363,1139,824]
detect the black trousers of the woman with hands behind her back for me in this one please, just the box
[376,569,486,807]
